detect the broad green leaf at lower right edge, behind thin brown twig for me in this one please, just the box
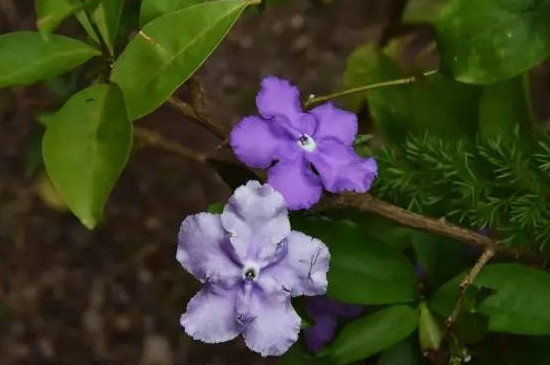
[431,264,550,335]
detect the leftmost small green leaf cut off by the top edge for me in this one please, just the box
[35,0,100,34]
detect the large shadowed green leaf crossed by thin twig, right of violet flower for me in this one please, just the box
[344,44,481,143]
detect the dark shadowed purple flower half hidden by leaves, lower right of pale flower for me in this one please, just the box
[305,296,363,353]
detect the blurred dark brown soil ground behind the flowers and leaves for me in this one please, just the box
[0,0,402,365]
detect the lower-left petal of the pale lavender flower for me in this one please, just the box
[180,285,239,343]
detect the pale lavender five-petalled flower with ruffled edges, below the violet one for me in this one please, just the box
[177,181,330,356]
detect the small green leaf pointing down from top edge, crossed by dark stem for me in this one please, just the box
[76,0,124,53]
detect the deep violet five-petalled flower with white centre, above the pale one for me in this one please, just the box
[231,76,377,209]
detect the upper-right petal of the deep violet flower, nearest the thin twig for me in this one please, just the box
[310,103,357,145]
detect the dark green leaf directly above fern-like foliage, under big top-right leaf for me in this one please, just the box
[479,76,531,145]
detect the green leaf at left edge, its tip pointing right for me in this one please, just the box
[0,32,99,88]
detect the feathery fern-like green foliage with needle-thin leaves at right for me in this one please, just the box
[373,135,550,255]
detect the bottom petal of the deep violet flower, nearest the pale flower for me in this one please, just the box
[267,159,323,210]
